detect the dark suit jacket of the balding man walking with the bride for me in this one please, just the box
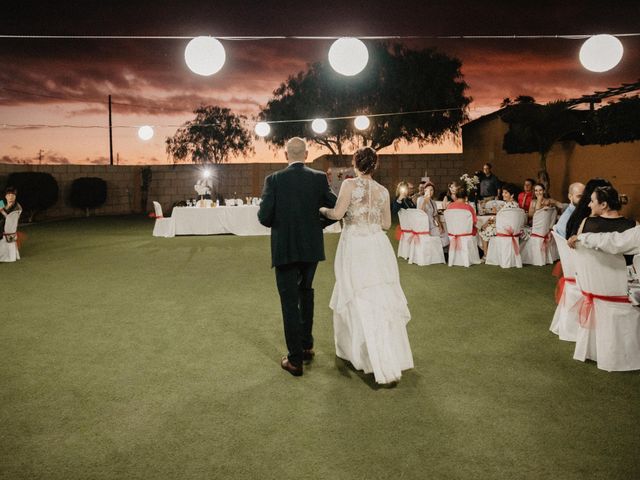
[258,163,336,267]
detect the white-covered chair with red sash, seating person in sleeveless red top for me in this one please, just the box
[444,210,480,267]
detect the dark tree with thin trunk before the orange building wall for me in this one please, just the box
[501,100,581,188]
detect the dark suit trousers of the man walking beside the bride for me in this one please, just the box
[275,262,318,366]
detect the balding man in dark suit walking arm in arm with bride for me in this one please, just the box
[258,137,336,376]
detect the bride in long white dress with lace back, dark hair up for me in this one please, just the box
[320,147,413,383]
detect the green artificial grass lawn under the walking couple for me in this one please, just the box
[0,217,640,480]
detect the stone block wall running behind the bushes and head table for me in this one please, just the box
[0,154,464,219]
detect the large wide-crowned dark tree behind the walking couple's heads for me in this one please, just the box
[259,42,471,154]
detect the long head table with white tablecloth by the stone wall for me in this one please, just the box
[171,205,340,236]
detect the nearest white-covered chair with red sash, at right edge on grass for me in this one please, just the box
[573,244,640,372]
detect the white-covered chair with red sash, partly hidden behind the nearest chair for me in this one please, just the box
[549,230,582,342]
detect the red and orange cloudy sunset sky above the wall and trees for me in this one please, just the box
[0,0,640,164]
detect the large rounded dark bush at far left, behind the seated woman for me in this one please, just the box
[7,172,58,222]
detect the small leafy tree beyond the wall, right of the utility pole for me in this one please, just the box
[165,105,253,164]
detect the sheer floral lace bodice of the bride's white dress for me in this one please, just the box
[327,177,391,229]
